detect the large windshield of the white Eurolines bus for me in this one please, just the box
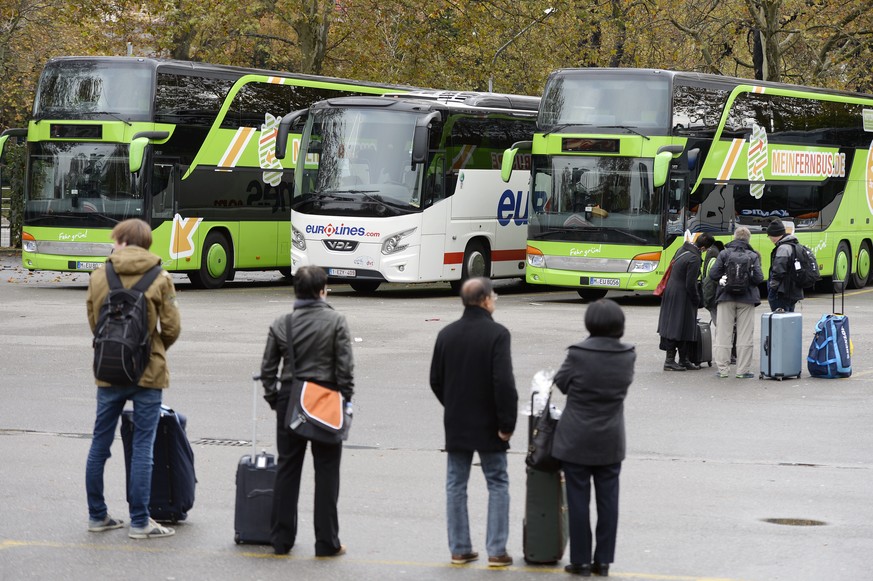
[292,108,421,216]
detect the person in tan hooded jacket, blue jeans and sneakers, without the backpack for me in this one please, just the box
[85,218,182,539]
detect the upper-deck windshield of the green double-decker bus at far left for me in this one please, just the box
[33,59,154,121]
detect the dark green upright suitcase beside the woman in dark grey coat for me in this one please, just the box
[522,467,569,564]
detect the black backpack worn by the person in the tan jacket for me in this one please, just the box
[94,260,161,386]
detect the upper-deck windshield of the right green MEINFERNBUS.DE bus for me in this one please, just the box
[538,71,670,135]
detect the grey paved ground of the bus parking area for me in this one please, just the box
[0,254,873,581]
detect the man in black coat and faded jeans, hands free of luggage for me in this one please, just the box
[430,278,518,567]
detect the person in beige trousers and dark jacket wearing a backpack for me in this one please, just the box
[709,226,764,379]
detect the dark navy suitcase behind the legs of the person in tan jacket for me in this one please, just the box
[121,406,197,523]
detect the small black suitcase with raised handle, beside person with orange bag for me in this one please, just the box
[233,375,276,545]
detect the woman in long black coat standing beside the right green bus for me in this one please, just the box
[658,237,701,371]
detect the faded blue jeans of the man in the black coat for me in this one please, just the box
[446,451,509,557]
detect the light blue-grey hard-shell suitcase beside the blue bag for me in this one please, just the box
[760,311,803,381]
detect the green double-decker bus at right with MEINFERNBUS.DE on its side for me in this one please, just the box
[503,68,873,299]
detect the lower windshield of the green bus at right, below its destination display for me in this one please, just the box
[528,155,662,245]
